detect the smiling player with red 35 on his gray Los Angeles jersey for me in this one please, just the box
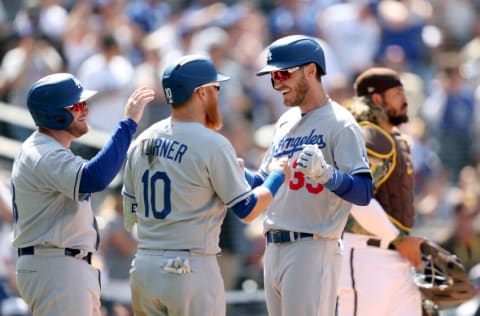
[250,35,373,316]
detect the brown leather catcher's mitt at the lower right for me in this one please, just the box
[415,240,474,309]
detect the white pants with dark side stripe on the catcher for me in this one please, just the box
[338,233,422,316]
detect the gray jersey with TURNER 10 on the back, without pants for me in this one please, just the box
[123,118,251,254]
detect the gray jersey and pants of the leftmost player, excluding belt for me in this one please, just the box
[12,131,101,316]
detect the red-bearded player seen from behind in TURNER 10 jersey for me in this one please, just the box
[123,55,290,316]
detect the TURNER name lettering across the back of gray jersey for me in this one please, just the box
[141,137,188,163]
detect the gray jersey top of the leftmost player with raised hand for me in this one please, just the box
[12,131,97,252]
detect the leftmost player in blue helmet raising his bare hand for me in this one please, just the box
[12,73,154,316]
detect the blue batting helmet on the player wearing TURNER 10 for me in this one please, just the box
[162,55,230,104]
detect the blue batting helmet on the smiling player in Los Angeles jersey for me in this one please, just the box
[257,35,327,76]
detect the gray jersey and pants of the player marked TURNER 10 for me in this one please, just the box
[123,118,252,315]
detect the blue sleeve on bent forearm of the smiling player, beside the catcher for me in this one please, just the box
[324,169,373,205]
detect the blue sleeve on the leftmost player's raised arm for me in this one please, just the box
[80,119,137,193]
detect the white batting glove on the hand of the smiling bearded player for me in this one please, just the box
[295,145,333,184]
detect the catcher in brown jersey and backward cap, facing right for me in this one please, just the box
[338,67,424,316]
